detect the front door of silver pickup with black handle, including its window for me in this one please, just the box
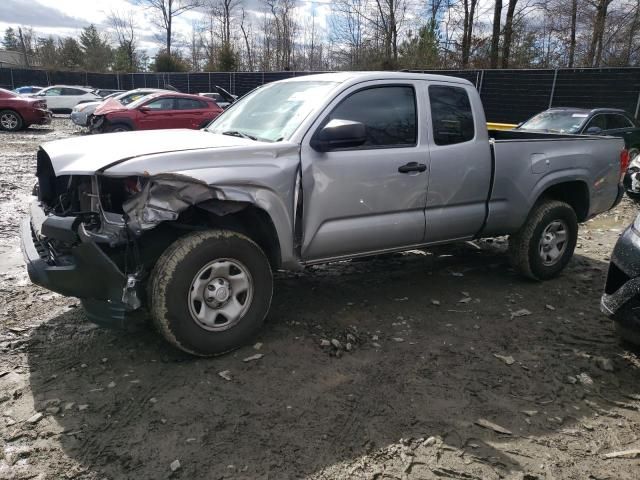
[301,81,428,261]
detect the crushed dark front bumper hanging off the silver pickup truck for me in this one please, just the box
[20,201,141,327]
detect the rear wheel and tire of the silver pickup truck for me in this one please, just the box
[509,200,578,280]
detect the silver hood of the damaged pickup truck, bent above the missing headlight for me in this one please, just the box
[40,129,258,176]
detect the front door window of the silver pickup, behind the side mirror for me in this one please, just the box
[327,86,417,149]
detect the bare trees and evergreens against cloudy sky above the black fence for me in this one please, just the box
[2,0,640,72]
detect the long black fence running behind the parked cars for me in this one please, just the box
[0,68,640,123]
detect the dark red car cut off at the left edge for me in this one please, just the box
[0,88,51,132]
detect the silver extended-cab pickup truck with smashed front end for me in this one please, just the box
[22,72,628,356]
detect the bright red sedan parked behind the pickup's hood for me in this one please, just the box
[89,92,223,133]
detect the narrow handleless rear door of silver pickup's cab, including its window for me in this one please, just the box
[425,83,492,243]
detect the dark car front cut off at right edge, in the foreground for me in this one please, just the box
[600,211,640,346]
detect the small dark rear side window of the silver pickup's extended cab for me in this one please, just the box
[429,85,475,145]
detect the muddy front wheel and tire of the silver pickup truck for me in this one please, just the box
[150,230,273,357]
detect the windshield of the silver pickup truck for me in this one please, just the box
[207,81,336,142]
